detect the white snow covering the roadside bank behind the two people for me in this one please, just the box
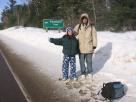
[0,27,136,102]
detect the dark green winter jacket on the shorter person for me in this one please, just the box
[50,35,79,56]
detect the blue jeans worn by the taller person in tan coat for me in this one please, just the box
[79,53,93,75]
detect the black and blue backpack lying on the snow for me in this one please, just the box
[98,82,125,101]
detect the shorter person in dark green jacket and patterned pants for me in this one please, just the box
[49,27,79,80]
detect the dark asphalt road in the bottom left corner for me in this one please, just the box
[0,51,27,102]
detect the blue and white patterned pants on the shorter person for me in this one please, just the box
[62,55,76,79]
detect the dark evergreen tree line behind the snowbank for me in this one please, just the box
[0,0,136,31]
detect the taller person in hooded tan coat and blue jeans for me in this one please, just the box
[74,13,97,78]
